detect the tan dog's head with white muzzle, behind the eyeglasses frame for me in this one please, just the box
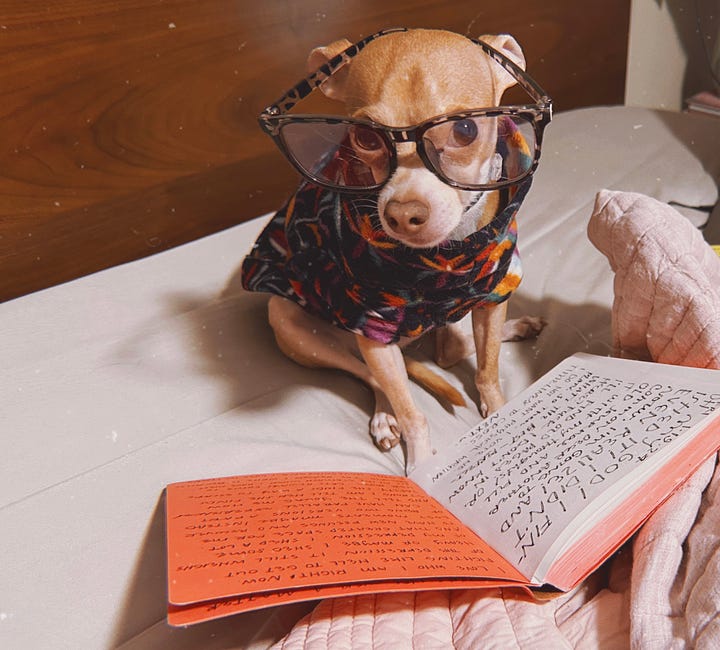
[308,29,525,248]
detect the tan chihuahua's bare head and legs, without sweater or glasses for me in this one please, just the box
[256,30,542,471]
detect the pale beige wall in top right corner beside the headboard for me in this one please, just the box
[625,0,720,110]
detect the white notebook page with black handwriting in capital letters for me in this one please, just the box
[410,354,720,576]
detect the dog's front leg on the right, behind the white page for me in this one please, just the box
[472,301,507,417]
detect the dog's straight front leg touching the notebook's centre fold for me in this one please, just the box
[356,335,432,473]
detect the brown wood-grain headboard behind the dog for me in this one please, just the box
[0,0,630,301]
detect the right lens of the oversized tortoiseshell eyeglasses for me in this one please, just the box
[423,115,535,188]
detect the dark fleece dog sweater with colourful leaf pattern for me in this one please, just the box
[242,172,531,343]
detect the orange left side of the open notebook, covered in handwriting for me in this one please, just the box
[167,472,526,625]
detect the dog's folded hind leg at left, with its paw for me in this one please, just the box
[268,296,400,451]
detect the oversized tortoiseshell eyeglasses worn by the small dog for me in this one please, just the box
[258,28,552,192]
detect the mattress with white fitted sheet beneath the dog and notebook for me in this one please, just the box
[0,107,720,649]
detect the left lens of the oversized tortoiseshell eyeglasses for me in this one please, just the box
[280,121,391,188]
